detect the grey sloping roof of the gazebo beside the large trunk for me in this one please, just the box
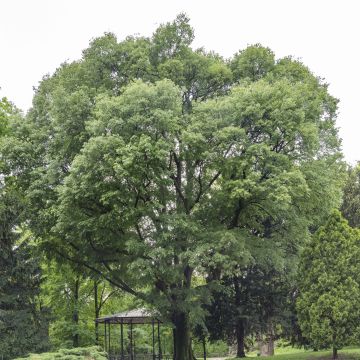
[95,309,159,324]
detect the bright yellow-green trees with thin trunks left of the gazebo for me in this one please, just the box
[41,259,119,348]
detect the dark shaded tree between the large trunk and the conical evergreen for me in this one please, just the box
[205,249,297,357]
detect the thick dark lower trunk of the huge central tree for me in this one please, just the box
[173,313,195,360]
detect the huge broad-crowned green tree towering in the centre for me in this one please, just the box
[2,15,339,360]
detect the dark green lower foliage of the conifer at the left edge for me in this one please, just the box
[0,226,49,360]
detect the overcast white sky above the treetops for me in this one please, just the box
[0,0,360,163]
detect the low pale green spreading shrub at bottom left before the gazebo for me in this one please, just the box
[15,346,107,360]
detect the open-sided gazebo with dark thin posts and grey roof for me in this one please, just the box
[95,309,163,360]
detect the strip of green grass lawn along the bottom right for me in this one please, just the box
[232,347,360,360]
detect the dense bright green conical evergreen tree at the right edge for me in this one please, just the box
[297,211,360,349]
